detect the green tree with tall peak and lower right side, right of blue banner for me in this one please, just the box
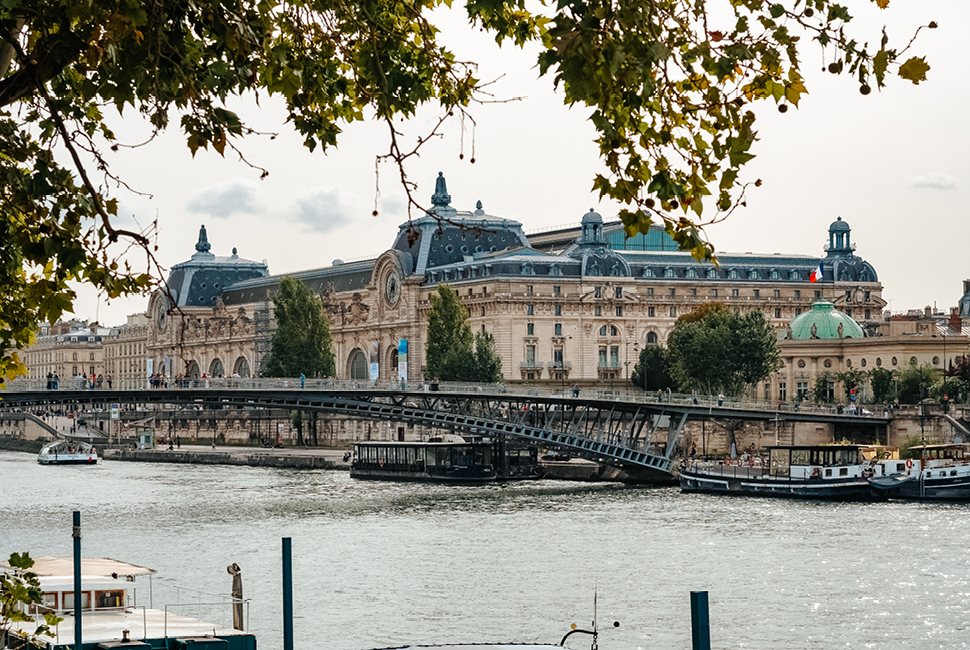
[425,284,502,383]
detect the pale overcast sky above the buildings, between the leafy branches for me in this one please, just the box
[64,0,970,325]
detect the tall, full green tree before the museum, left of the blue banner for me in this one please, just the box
[263,277,336,377]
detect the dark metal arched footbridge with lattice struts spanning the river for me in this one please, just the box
[0,378,888,482]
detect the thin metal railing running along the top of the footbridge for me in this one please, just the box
[0,377,883,416]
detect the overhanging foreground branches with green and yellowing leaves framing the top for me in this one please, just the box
[0,0,936,378]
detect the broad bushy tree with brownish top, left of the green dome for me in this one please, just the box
[667,302,779,397]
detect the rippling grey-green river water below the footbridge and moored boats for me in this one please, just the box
[0,452,970,650]
